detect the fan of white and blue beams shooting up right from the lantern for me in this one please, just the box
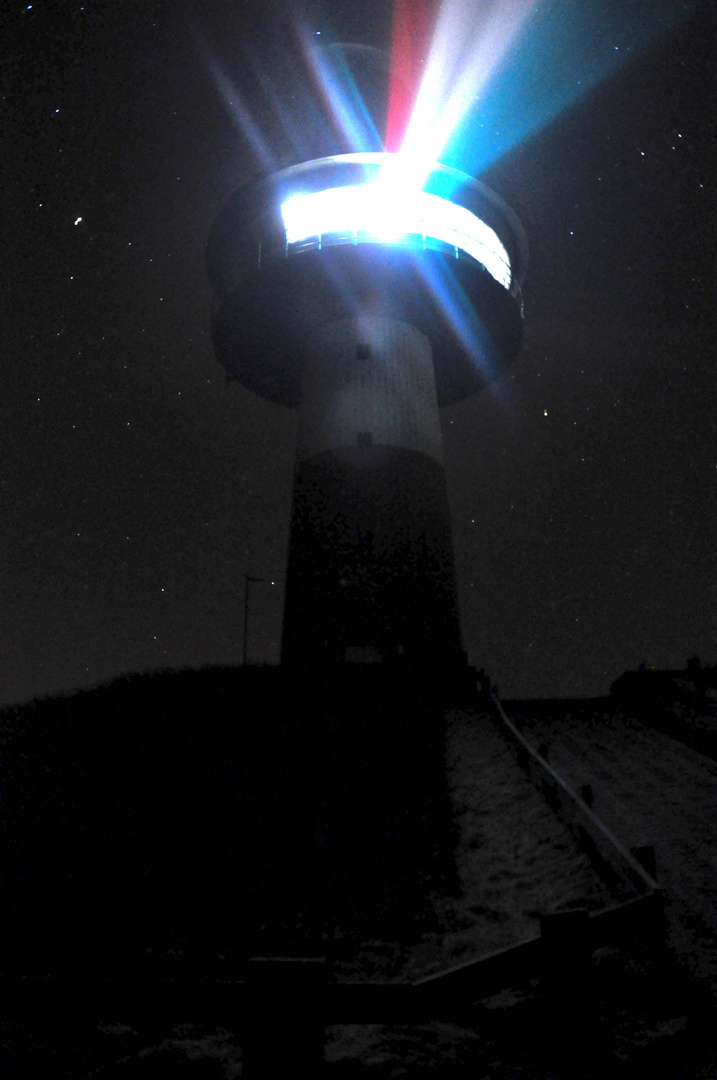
[389,0,700,175]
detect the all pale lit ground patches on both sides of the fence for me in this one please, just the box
[5,703,717,1080]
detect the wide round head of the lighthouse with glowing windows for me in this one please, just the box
[207,153,527,406]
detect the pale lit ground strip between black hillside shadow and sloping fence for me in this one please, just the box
[330,712,617,982]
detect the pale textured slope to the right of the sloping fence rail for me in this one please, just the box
[509,704,717,993]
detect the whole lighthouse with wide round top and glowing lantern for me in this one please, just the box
[207,152,526,669]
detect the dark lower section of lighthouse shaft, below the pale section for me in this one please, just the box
[282,445,465,669]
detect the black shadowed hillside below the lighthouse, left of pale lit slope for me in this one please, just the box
[0,665,454,974]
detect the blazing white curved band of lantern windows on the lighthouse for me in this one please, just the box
[282,182,511,288]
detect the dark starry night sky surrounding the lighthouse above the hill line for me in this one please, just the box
[0,0,717,704]
